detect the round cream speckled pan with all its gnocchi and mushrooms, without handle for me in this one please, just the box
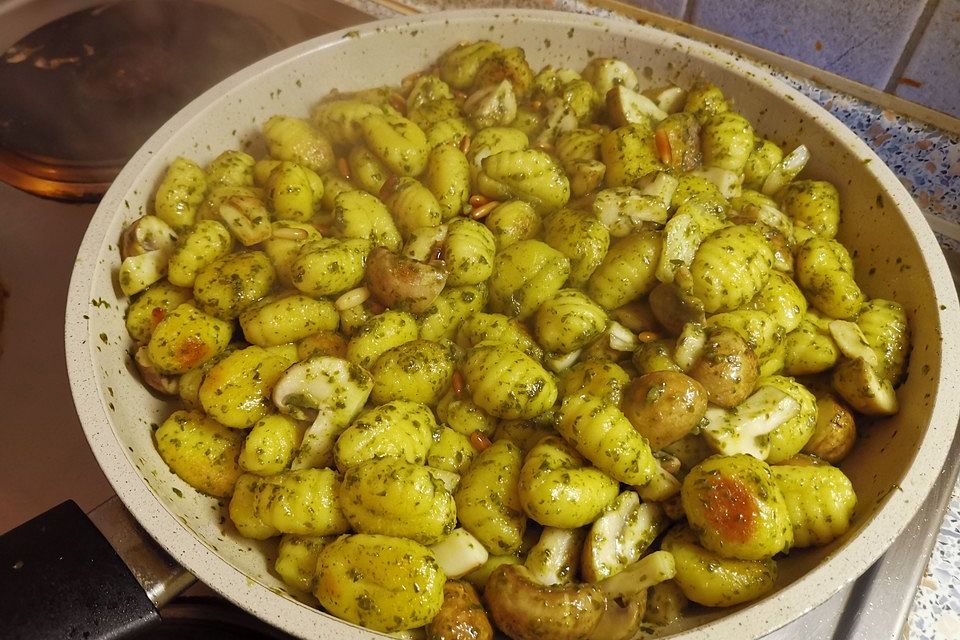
[66,10,960,640]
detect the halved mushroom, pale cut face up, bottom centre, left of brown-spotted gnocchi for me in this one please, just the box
[580,491,667,582]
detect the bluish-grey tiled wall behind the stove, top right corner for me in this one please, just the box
[628,0,960,117]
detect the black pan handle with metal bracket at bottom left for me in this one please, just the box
[0,497,195,640]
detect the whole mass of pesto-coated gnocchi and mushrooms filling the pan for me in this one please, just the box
[124,41,911,640]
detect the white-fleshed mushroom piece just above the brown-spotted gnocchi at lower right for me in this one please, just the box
[700,386,800,460]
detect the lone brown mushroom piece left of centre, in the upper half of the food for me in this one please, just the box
[367,247,447,313]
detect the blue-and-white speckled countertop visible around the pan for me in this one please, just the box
[340,0,960,640]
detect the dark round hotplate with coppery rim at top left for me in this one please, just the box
[0,0,290,200]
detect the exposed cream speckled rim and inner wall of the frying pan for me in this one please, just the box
[60,10,960,640]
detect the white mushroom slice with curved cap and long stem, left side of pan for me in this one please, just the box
[273,355,373,469]
